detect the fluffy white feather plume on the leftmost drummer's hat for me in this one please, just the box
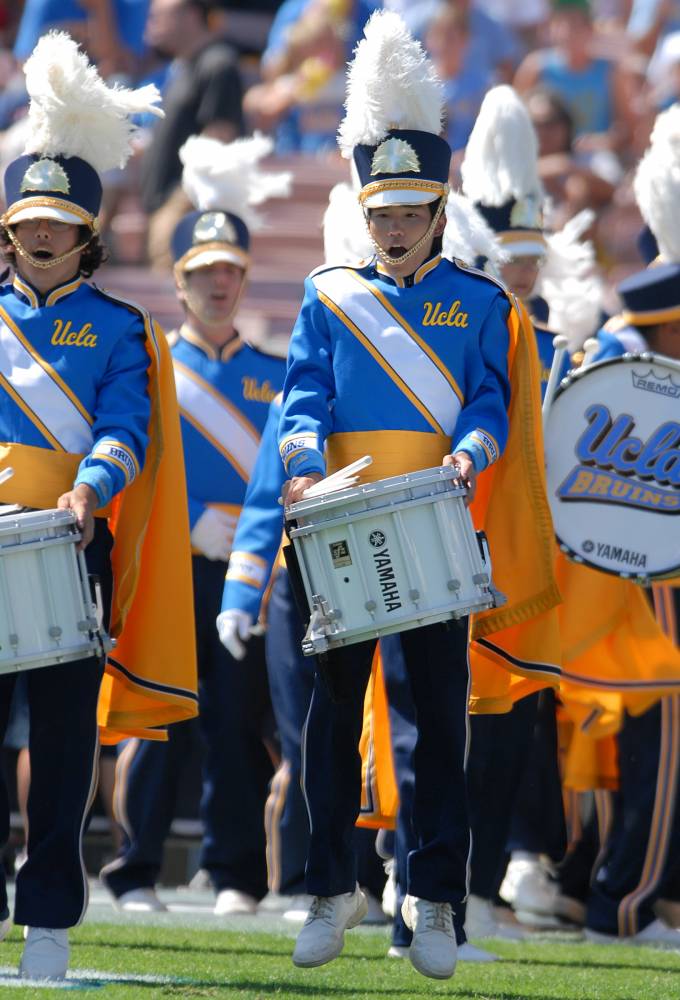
[24,31,163,173]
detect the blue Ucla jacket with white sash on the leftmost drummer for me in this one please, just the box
[0,275,150,506]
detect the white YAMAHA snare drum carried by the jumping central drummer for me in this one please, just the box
[286,467,503,656]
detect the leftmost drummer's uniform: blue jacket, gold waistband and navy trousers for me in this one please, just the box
[0,276,151,928]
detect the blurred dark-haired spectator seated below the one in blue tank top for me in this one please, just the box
[526,89,622,228]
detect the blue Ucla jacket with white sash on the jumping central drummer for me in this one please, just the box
[279,256,511,476]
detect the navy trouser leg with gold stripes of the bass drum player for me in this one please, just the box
[586,695,680,937]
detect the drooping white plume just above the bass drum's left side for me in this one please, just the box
[535,209,604,354]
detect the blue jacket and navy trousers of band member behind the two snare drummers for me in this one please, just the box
[102,325,284,899]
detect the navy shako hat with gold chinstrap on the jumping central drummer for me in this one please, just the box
[352,129,451,208]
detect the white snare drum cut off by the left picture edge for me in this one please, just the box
[0,510,111,673]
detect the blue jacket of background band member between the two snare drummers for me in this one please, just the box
[170,325,285,528]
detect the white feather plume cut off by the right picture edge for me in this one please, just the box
[633,104,680,262]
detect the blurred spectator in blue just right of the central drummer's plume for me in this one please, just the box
[425,3,495,153]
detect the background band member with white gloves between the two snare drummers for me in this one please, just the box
[101,136,290,916]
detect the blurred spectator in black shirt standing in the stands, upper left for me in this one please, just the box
[141,0,243,268]
